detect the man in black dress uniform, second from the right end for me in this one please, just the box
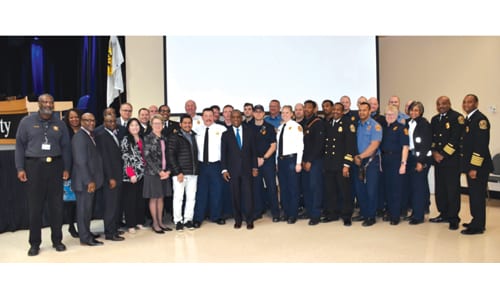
[429,96,464,230]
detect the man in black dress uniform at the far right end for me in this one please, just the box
[461,94,493,234]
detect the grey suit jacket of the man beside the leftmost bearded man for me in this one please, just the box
[71,130,104,192]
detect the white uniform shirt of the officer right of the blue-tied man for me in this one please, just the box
[276,120,304,164]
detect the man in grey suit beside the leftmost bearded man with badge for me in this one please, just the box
[71,113,104,246]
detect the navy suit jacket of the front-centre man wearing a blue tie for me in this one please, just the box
[221,123,257,177]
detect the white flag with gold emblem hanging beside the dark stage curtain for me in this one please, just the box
[106,36,125,106]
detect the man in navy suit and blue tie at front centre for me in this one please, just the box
[221,110,258,229]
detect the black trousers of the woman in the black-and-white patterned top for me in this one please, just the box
[122,179,145,228]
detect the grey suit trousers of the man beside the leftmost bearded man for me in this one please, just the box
[75,191,95,243]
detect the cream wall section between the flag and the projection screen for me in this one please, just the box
[125,36,164,116]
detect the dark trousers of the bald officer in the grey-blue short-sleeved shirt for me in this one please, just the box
[353,155,380,218]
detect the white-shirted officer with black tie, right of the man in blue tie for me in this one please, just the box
[276,105,304,224]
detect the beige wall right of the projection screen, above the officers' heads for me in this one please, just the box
[379,37,500,155]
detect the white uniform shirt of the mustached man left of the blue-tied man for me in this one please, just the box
[193,123,227,162]
